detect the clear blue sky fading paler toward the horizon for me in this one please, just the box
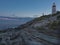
[0,0,60,17]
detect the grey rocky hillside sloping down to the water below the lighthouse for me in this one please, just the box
[0,12,60,45]
